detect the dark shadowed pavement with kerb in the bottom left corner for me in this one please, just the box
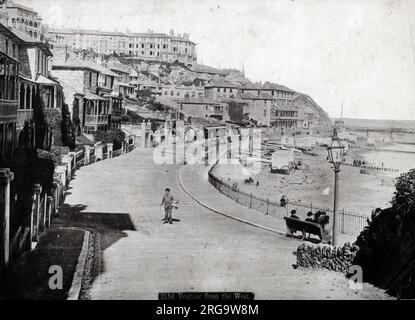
[0,226,86,300]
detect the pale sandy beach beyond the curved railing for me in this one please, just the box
[215,148,395,215]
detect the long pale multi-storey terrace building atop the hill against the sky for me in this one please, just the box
[47,29,197,64]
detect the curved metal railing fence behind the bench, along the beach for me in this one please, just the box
[209,164,368,235]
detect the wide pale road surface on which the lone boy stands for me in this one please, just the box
[61,149,386,299]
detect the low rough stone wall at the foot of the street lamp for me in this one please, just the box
[297,243,359,273]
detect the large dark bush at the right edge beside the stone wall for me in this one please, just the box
[353,169,415,298]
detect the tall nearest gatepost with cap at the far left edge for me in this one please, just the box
[0,169,14,275]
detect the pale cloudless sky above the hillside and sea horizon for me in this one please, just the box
[15,0,415,120]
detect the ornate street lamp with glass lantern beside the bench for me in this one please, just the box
[327,128,344,246]
